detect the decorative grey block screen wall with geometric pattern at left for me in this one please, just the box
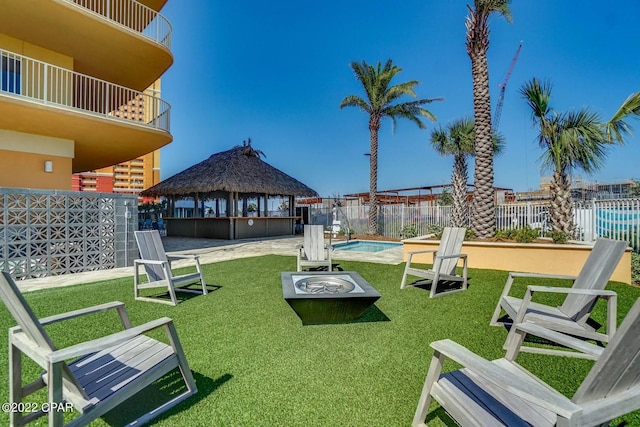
[0,188,137,280]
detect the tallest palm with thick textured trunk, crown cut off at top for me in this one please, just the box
[465,0,511,238]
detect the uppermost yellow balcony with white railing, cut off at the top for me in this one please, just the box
[0,0,173,90]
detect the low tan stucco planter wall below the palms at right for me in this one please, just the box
[403,239,631,284]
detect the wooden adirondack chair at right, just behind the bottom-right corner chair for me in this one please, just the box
[490,239,628,357]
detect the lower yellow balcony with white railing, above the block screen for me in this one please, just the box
[0,49,171,176]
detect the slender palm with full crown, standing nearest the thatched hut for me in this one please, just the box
[340,59,442,234]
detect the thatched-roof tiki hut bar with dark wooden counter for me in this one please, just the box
[141,139,318,239]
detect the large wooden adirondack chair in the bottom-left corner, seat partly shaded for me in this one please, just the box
[0,273,197,426]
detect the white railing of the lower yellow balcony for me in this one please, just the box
[0,49,171,132]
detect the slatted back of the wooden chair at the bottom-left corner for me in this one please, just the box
[0,272,87,398]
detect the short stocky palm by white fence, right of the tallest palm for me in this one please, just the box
[520,78,640,236]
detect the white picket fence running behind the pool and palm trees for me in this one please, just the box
[311,199,640,250]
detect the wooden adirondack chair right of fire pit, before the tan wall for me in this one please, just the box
[400,227,467,298]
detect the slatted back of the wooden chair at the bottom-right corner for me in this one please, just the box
[572,299,640,404]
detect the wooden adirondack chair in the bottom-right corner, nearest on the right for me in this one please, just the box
[413,300,640,427]
